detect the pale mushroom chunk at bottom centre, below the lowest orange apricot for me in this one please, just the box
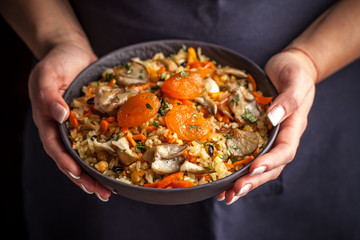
[142,144,187,174]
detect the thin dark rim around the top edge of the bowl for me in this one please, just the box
[58,39,280,195]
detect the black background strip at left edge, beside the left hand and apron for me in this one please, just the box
[0,18,33,239]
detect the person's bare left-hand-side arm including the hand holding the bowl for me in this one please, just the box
[0,0,110,200]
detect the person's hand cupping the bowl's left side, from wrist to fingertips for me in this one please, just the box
[29,43,111,201]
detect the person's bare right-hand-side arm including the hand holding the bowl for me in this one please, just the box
[222,0,360,204]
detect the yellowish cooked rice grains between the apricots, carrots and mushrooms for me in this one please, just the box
[66,44,270,186]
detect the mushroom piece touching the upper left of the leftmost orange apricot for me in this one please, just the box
[94,86,135,116]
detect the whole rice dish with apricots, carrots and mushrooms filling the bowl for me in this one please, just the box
[66,46,272,188]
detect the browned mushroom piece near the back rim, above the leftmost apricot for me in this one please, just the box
[113,62,149,86]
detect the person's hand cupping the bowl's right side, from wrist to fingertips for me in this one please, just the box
[218,50,317,204]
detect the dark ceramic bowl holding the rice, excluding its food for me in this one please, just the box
[59,40,279,205]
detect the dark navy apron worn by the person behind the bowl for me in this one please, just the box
[23,0,360,240]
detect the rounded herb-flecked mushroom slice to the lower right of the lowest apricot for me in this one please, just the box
[226,128,260,157]
